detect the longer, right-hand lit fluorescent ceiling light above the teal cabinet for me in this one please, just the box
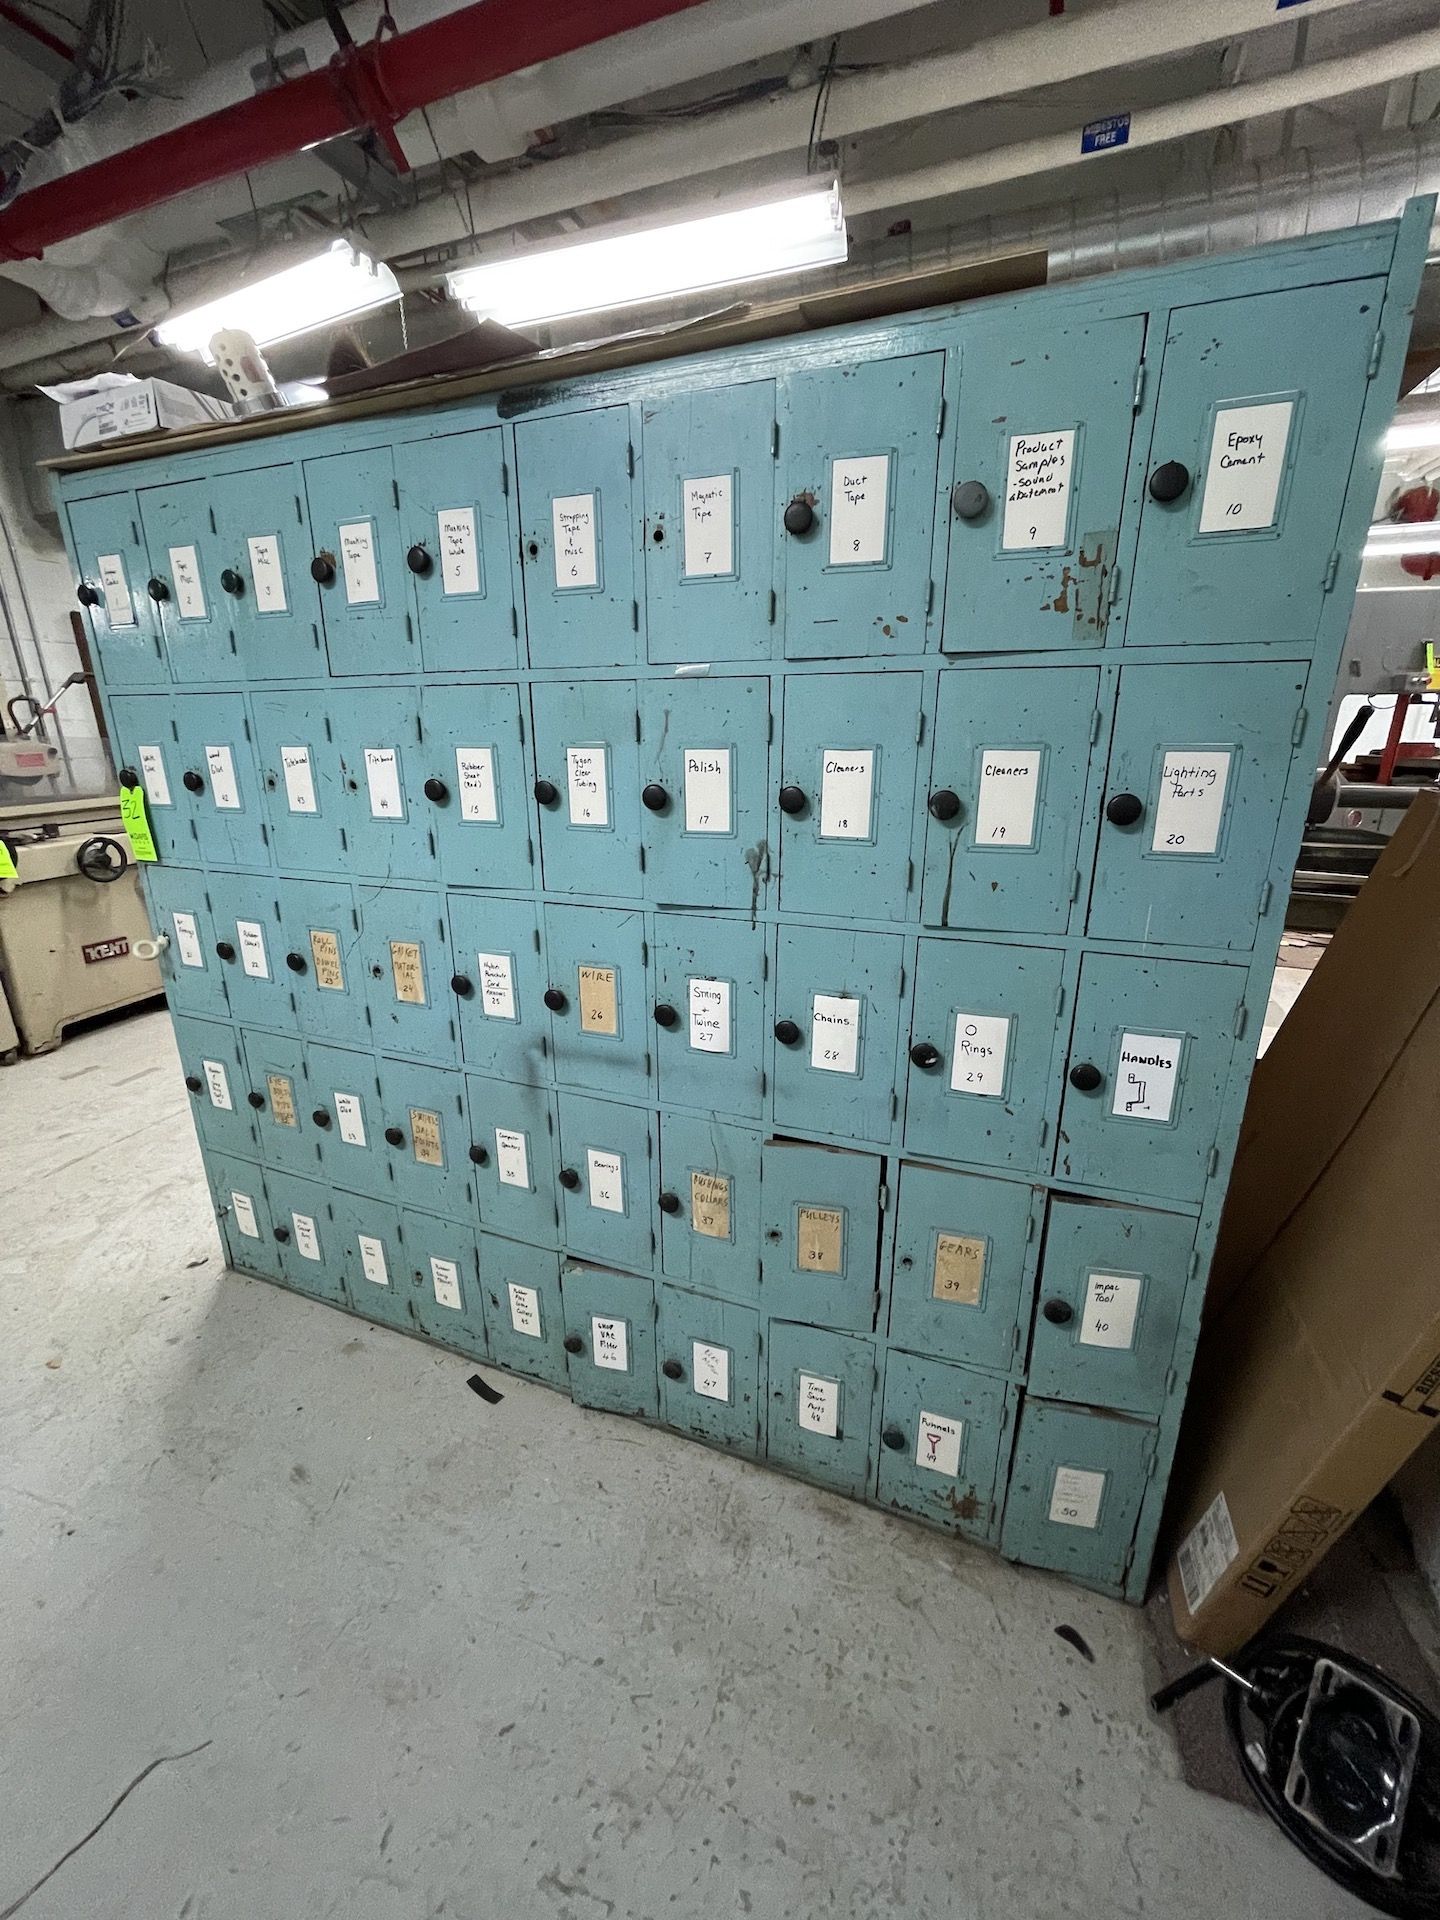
[449,186,849,326]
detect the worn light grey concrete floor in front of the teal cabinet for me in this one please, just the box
[0,1014,1365,1920]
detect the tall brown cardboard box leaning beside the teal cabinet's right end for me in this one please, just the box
[1169,793,1440,1655]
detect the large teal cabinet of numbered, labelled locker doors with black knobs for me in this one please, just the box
[73,202,1434,1601]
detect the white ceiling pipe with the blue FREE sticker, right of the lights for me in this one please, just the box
[843,27,1440,215]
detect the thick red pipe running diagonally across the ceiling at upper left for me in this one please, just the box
[0,0,718,259]
